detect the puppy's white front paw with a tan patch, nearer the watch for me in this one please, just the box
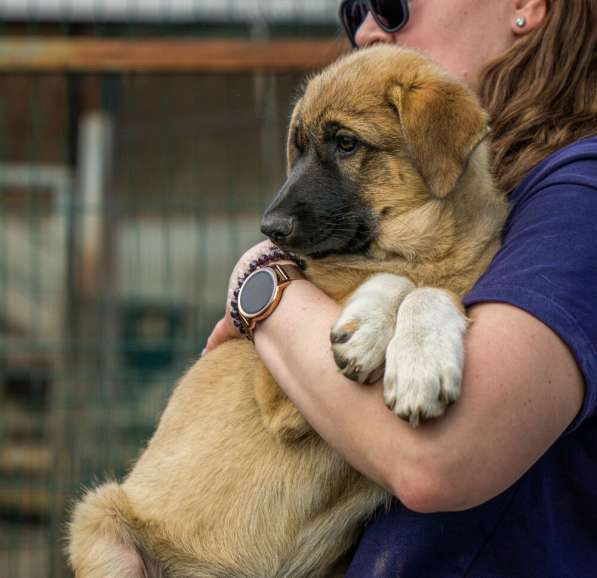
[330,273,414,383]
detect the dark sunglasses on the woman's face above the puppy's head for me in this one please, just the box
[340,0,408,47]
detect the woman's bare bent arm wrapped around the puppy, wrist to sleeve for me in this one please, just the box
[255,281,584,512]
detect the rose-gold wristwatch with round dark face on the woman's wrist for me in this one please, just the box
[238,263,305,341]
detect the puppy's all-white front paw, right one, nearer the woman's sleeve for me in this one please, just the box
[384,288,467,427]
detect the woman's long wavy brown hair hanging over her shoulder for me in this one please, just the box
[480,0,597,191]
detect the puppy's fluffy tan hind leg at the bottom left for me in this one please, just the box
[68,482,162,578]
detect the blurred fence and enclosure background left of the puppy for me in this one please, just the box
[0,0,348,578]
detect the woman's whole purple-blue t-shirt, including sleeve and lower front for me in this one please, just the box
[346,137,597,578]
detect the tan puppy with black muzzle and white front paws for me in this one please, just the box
[69,46,506,578]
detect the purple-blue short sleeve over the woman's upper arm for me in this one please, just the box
[464,154,597,431]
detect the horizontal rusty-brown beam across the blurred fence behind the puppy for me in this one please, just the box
[0,37,349,72]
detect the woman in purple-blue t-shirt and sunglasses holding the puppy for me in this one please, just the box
[207,0,597,578]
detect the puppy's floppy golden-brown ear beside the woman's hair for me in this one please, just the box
[389,79,489,198]
